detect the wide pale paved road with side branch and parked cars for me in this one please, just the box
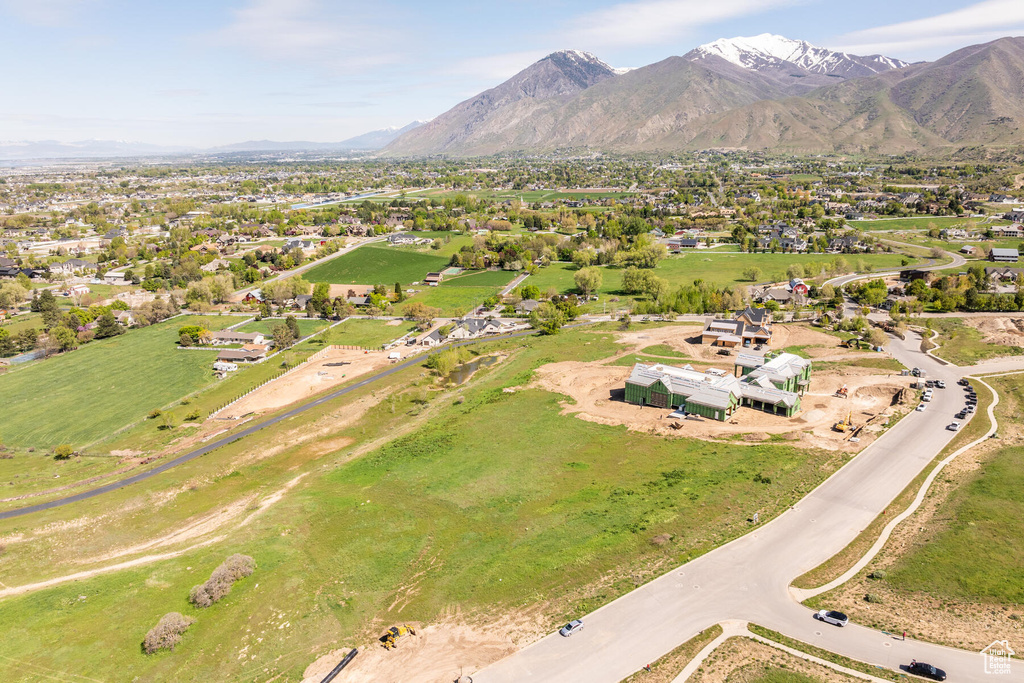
[473,334,1024,683]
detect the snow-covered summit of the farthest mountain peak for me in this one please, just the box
[686,33,908,78]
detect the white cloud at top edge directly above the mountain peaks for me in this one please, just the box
[561,0,803,50]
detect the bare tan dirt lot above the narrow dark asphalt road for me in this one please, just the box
[217,349,390,419]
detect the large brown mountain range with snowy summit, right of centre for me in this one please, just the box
[383,34,1024,157]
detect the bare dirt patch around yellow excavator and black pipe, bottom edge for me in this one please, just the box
[303,616,543,683]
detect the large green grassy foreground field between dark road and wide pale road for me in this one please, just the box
[0,331,843,681]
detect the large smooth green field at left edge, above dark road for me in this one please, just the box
[0,315,238,454]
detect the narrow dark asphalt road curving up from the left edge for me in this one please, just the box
[0,326,544,519]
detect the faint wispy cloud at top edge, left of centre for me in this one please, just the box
[214,0,398,70]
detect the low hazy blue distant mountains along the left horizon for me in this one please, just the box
[0,121,422,162]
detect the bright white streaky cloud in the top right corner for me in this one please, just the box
[833,0,1024,59]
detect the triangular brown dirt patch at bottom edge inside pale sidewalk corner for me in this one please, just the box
[690,638,860,683]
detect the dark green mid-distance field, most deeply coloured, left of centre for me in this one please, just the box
[303,247,449,287]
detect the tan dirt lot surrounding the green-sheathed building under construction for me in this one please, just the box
[537,326,909,451]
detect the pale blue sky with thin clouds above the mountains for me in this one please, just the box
[0,0,1024,146]
